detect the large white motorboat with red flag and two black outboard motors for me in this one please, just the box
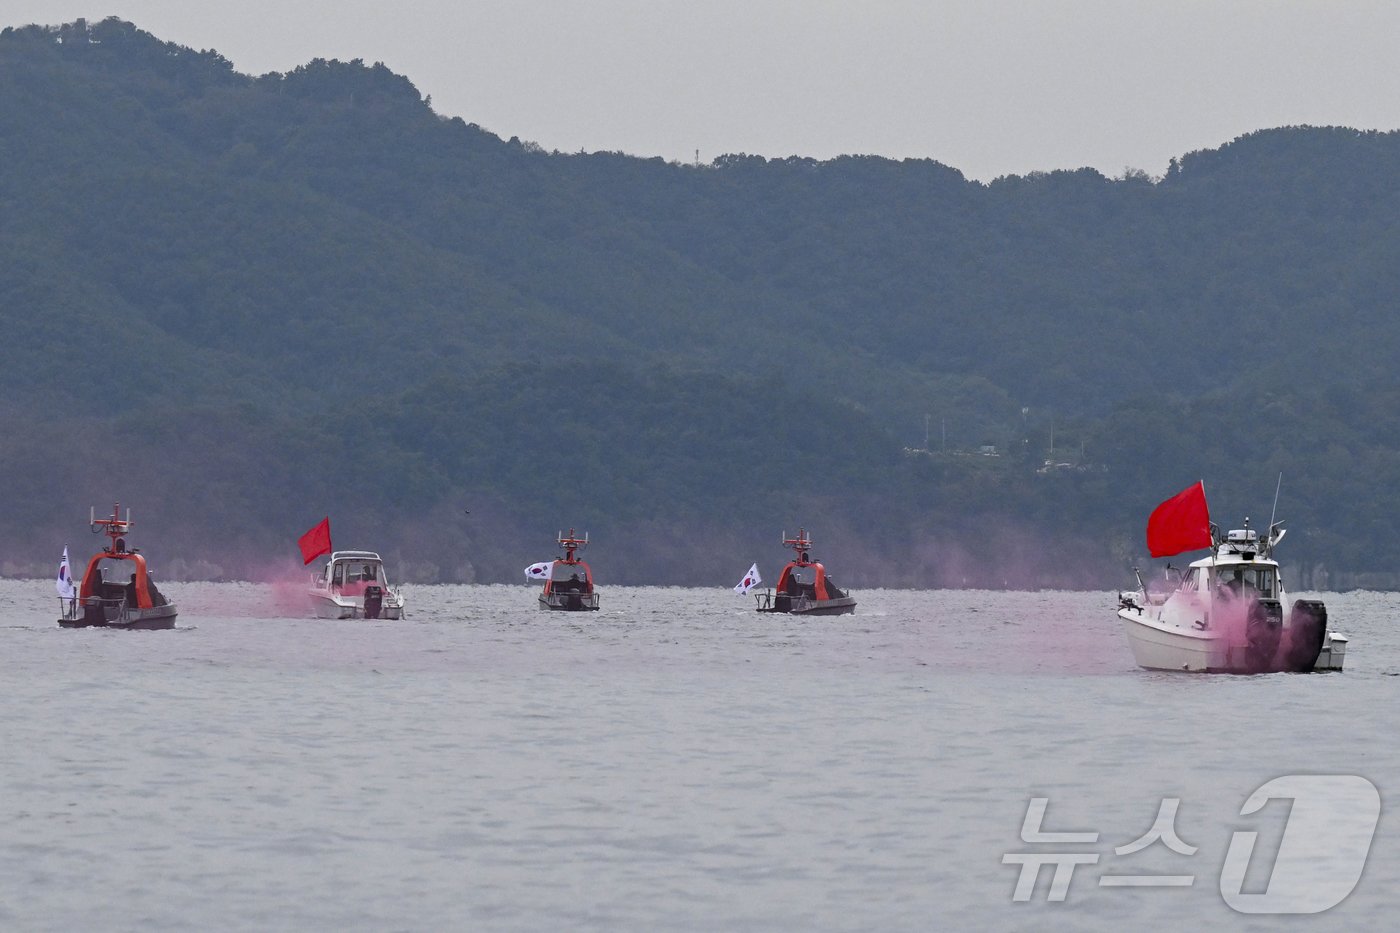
[1119,483,1347,674]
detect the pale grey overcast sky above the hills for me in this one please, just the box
[10,0,1400,179]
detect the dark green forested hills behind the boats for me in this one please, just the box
[0,20,1400,587]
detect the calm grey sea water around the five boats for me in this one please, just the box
[0,581,1400,930]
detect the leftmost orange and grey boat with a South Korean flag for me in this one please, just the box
[59,504,176,629]
